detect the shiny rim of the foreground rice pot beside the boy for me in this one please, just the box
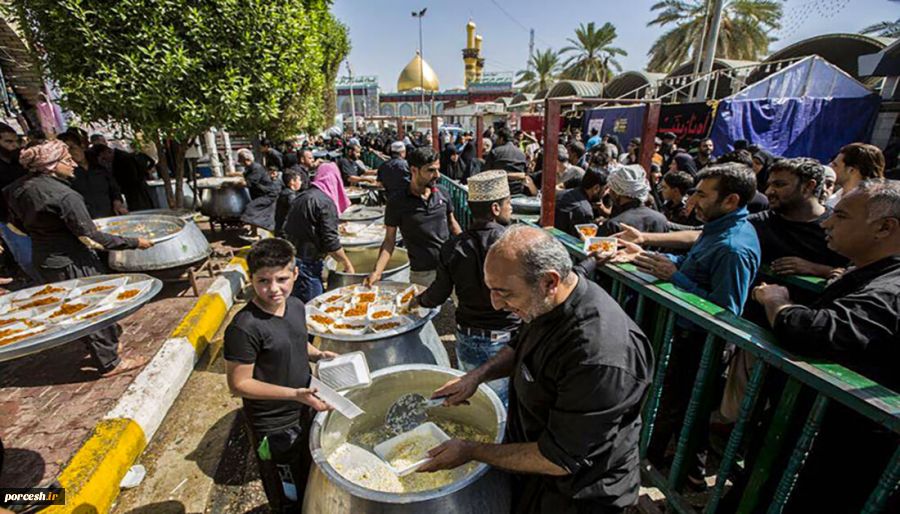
[309,364,506,504]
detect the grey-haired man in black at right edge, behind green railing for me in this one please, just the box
[753,179,900,512]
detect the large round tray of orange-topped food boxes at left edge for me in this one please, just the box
[0,274,162,362]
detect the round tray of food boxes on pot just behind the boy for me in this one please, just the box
[306,281,440,341]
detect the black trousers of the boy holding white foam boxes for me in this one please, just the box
[244,406,313,513]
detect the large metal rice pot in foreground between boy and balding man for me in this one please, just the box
[303,364,511,514]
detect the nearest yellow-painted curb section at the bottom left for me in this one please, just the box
[44,418,147,514]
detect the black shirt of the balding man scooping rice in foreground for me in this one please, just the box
[507,276,653,513]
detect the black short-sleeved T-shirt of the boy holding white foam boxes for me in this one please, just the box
[224,296,310,433]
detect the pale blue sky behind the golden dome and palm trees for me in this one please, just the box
[332,0,900,92]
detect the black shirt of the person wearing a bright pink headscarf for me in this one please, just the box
[282,186,342,260]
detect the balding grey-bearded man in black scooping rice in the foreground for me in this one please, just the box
[420,226,653,514]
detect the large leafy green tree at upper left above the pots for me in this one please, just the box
[7,0,343,205]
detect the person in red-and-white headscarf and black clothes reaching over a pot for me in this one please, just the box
[3,140,153,376]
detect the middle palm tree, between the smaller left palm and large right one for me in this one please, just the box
[560,22,628,84]
